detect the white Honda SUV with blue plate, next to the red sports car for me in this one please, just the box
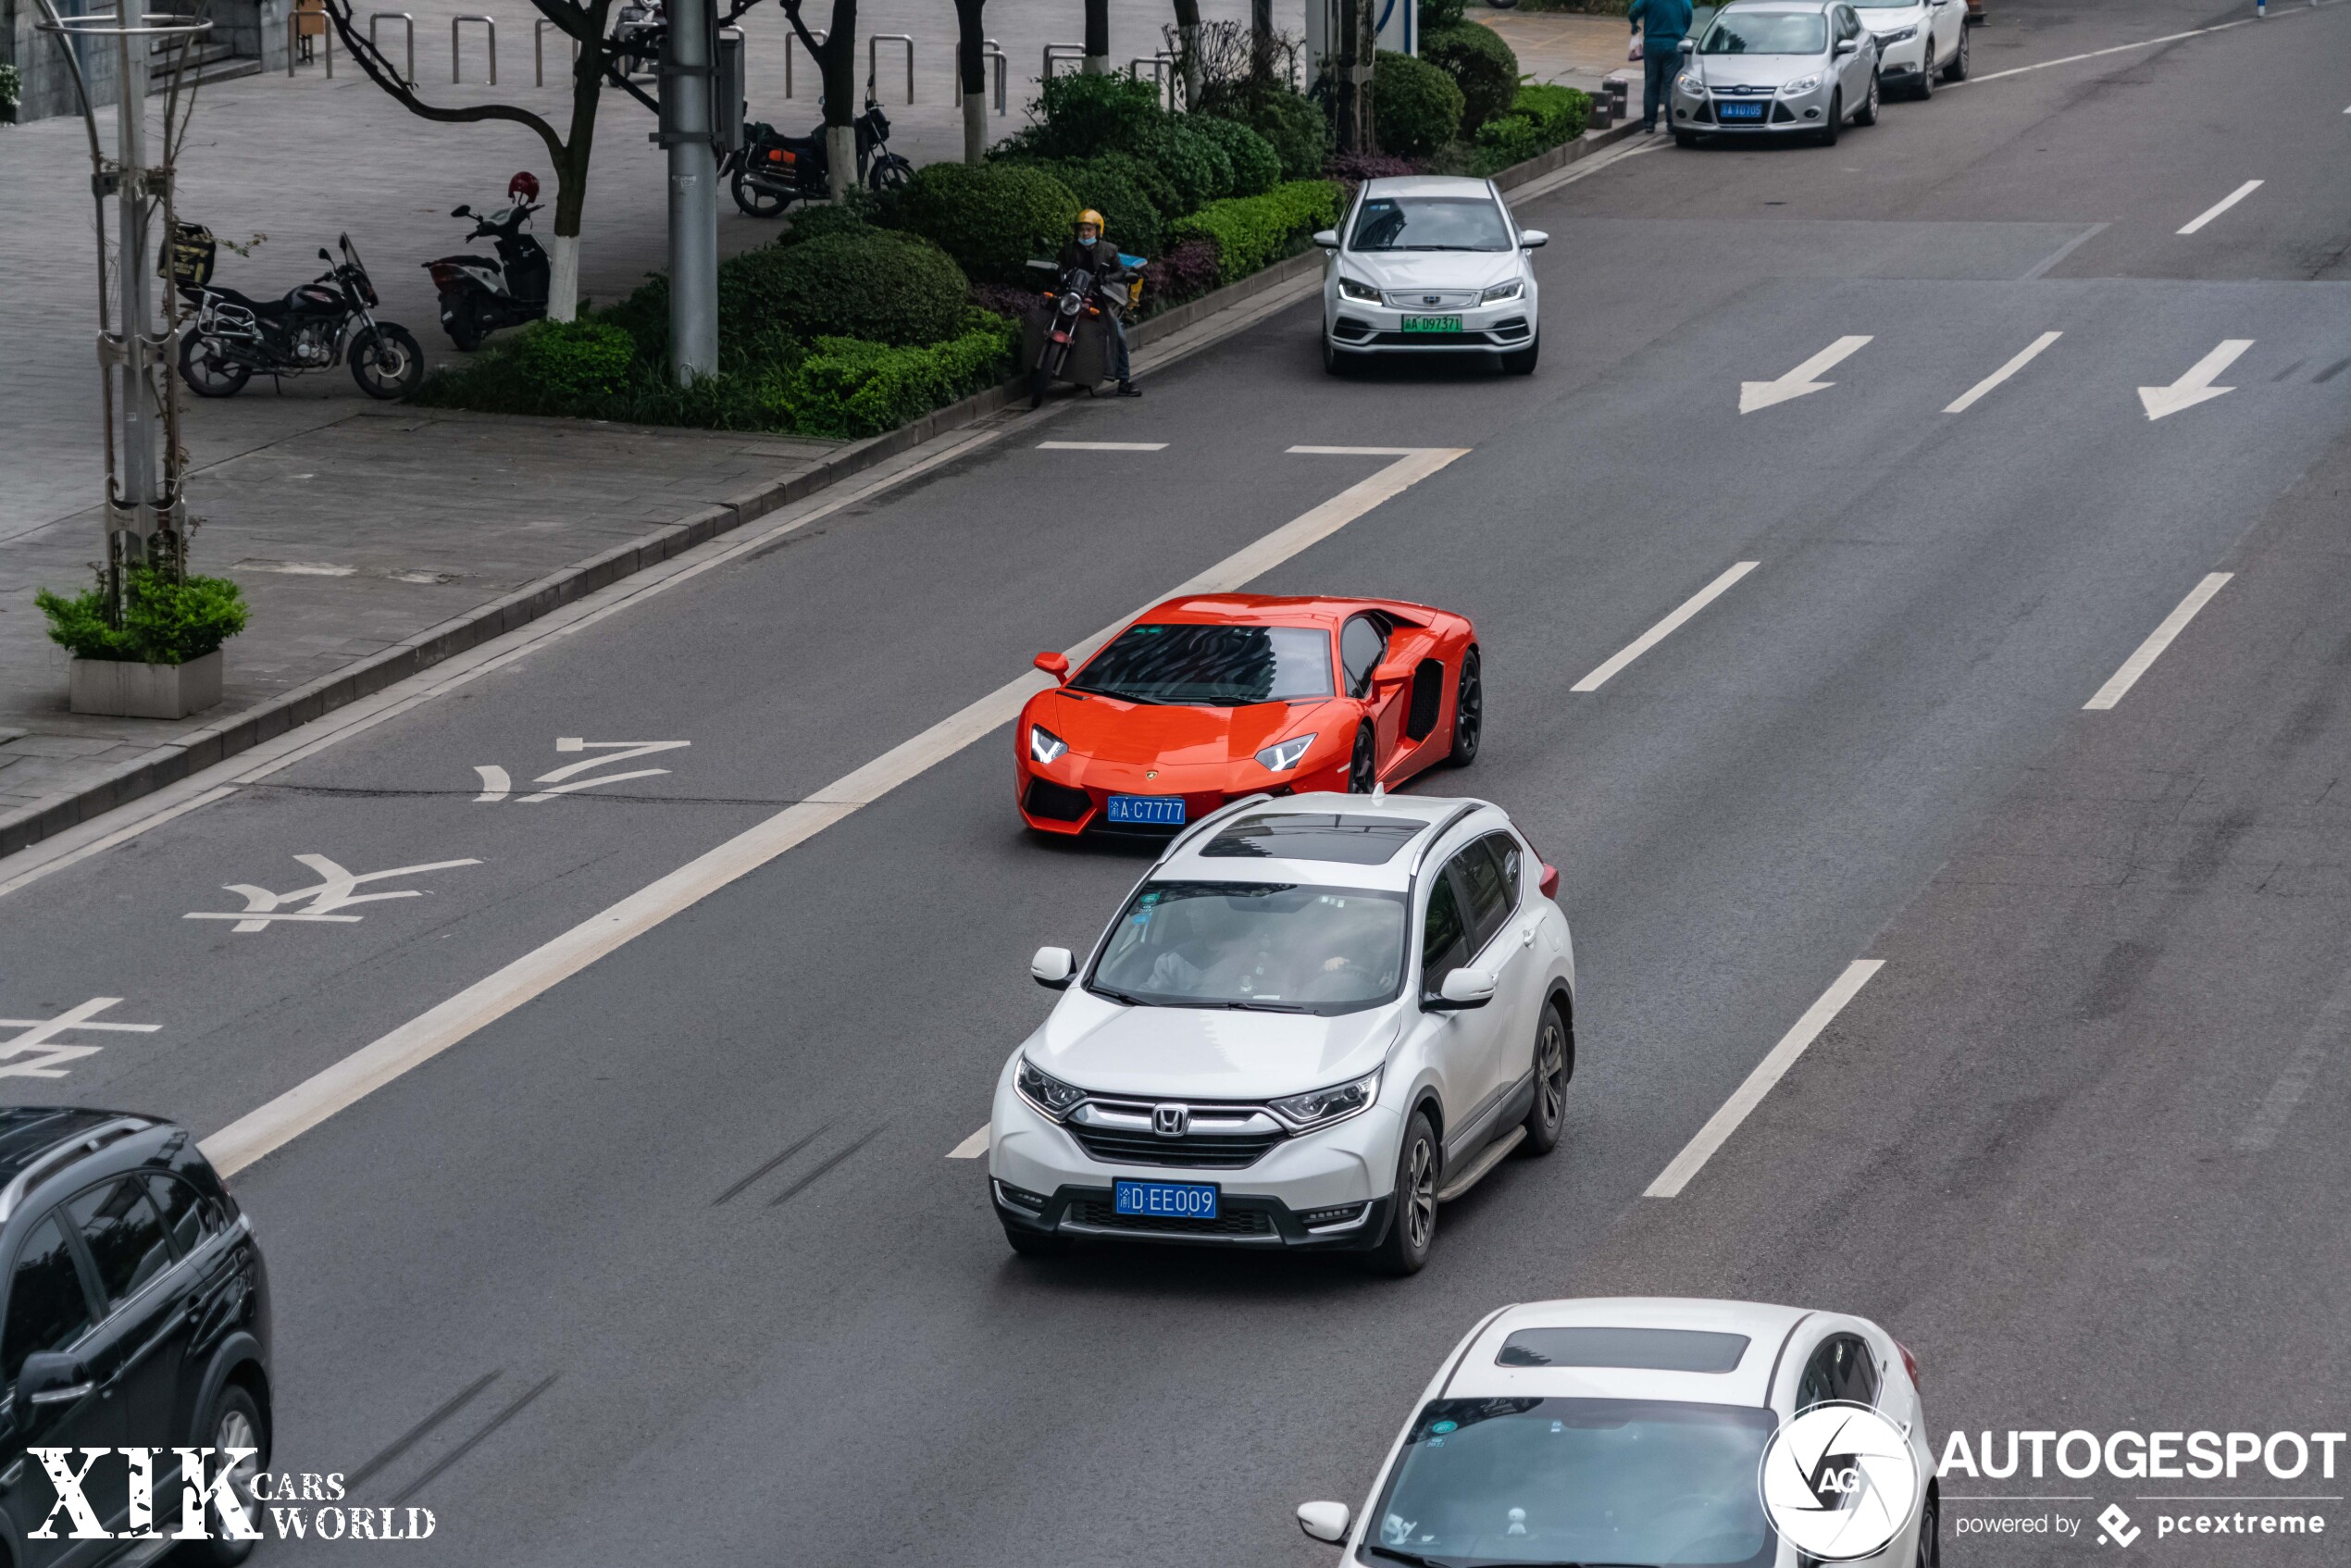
[988,790,1575,1275]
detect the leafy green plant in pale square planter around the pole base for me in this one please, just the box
[33,562,249,719]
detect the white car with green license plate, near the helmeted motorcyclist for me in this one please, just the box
[1314,174,1549,376]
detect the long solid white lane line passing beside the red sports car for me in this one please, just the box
[202,447,1467,1176]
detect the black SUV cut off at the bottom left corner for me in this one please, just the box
[0,1105,270,1568]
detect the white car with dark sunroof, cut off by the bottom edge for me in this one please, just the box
[1298,1298,1940,1568]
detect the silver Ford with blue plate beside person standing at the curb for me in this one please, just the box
[1673,0,1878,145]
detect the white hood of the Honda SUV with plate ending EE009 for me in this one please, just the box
[1023,988,1403,1101]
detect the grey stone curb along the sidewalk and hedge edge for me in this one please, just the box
[0,122,1634,855]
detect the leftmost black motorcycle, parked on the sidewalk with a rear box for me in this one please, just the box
[171,230,426,400]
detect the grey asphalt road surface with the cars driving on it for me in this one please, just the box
[0,0,2351,1568]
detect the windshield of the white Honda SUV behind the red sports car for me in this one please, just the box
[1086,881,1406,1015]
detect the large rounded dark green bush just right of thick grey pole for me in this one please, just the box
[715,226,971,345]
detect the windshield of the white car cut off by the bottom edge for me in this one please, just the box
[1362,1399,1777,1568]
